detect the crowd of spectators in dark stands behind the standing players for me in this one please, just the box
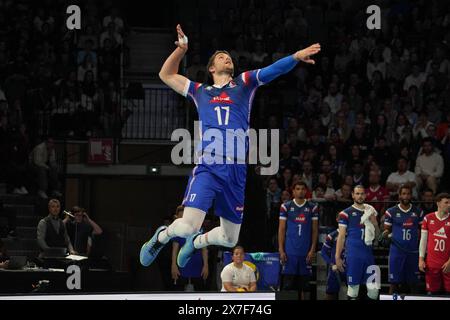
[181,0,450,248]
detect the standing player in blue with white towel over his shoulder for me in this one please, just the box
[335,185,380,300]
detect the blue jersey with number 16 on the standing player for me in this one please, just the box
[384,205,423,254]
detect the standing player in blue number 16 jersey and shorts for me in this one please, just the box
[383,186,423,294]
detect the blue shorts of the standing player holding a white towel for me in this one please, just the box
[345,255,375,286]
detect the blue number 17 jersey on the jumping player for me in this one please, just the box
[184,69,263,164]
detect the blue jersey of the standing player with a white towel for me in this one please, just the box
[339,206,373,257]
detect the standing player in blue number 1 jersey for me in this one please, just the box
[278,182,319,300]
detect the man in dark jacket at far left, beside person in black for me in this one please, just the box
[37,199,75,257]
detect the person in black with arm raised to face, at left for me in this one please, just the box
[63,206,103,256]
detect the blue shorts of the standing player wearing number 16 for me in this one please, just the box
[389,250,419,283]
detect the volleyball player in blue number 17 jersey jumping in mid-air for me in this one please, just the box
[140,25,320,267]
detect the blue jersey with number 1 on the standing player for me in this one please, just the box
[280,200,319,257]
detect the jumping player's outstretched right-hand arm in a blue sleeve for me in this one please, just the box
[258,43,320,83]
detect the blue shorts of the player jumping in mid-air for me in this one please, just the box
[183,164,247,224]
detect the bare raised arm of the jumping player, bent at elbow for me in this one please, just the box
[159,25,189,95]
